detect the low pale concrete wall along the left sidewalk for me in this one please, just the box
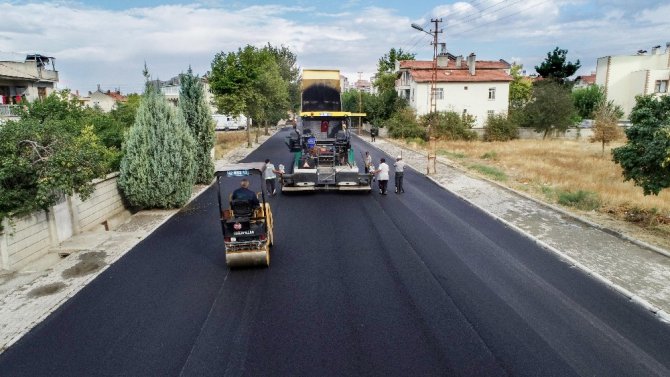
[0,173,125,270]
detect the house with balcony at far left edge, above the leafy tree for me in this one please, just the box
[0,54,58,117]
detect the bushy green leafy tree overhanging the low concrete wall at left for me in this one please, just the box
[0,92,110,223]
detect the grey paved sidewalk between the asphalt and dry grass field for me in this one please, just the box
[360,137,670,323]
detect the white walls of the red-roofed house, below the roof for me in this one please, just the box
[410,82,509,127]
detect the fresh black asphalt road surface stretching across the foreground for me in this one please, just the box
[0,131,670,376]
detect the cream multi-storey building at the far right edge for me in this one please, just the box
[596,42,670,118]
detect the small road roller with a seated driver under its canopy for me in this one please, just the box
[216,162,273,268]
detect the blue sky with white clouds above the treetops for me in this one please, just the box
[0,0,670,93]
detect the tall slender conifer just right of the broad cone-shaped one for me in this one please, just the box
[179,67,214,184]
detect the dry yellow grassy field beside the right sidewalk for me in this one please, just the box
[404,140,670,246]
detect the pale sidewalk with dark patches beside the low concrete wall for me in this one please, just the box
[0,136,276,353]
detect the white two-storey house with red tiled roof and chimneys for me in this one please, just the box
[396,53,512,127]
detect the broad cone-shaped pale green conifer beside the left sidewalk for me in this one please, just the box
[118,82,195,208]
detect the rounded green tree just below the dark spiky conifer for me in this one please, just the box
[524,81,575,139]
